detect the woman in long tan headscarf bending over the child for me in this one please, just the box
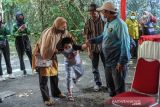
[32,17,71,105]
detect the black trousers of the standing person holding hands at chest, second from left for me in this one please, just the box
[15,36,32,70]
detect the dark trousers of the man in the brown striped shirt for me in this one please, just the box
[92,52,105,86]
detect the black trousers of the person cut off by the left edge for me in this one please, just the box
[0,40,12,75]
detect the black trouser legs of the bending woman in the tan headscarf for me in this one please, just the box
[39,74,61,101]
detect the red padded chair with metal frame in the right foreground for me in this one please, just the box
[106,58,160,107]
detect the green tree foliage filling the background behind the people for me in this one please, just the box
[2,0,160,43]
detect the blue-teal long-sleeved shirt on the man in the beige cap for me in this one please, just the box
[90,17,131,66]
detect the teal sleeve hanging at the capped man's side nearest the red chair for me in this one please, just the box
[117,23,131,65]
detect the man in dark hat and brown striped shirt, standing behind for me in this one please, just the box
[84,3,105,91]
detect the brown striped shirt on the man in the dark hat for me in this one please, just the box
[84,17,105,53]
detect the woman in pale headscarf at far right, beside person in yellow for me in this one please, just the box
[139,11,156,35]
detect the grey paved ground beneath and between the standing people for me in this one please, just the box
[0,54,135,107]
